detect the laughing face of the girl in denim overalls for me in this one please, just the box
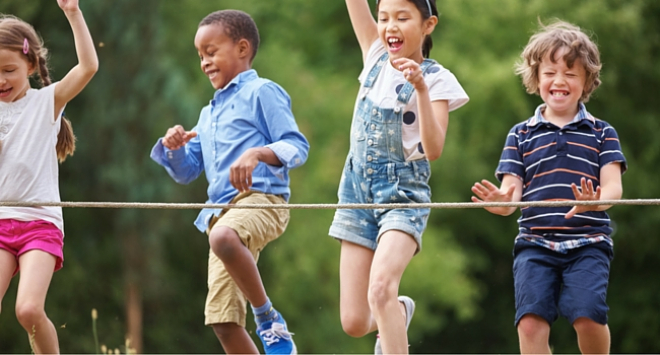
[378,0,437,63]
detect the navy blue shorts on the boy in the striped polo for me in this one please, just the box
[513,240,613,326]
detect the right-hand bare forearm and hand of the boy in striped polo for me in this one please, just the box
[565,163,623,218]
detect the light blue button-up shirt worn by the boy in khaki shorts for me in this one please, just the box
[151,70,309,232]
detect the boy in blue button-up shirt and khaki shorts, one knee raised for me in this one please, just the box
[151,10,309,354]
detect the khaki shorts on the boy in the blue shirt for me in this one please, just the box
[204,191,289,327]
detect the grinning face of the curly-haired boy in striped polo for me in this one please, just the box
[538,48,587,123]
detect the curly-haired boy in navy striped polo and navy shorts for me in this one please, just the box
[472,22,626,354]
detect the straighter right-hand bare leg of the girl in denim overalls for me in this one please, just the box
[368,230,417,354]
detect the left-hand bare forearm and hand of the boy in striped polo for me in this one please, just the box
[472,174,523,216]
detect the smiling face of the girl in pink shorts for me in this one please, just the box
[0,49,34,102]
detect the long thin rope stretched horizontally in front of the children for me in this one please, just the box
[0,199,660,210]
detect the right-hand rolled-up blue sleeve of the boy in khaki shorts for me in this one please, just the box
[258,82,309,179]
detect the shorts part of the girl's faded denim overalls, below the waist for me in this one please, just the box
[329,156,431,252]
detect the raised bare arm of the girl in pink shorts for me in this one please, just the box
[55,0,99,115]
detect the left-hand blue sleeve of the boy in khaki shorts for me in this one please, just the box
[150,128,204,184]
